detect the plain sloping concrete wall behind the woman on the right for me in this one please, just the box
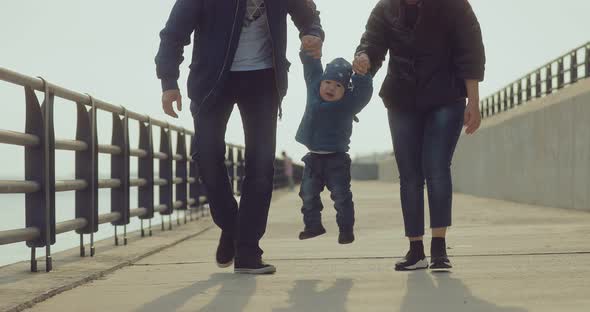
[453,80,590,211]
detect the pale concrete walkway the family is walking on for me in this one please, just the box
[20,182,590,312]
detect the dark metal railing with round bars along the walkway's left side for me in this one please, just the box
[0,67,302,272]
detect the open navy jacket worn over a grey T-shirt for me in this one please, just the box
[156,0,324,111]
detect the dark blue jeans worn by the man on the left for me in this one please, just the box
[191,69,280,261]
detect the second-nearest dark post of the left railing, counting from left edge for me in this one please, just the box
[76,96,98,257]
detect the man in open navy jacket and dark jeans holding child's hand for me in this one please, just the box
[156,0,324,274]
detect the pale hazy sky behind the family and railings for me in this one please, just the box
[0,0,590,173]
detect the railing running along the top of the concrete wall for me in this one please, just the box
[480,42,590,118]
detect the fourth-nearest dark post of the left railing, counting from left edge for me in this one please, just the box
[137,118,154,237]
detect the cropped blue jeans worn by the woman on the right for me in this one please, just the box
[388,101,465,237]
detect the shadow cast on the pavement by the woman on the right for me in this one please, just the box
[400,271,527,312]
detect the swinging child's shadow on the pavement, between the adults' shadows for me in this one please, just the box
[273,279,353,312]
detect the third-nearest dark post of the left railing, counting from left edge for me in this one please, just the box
[111,108,130,245]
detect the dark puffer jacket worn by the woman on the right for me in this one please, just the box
[357,0,485,110]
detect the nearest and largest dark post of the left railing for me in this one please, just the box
[25,84,55,272]
